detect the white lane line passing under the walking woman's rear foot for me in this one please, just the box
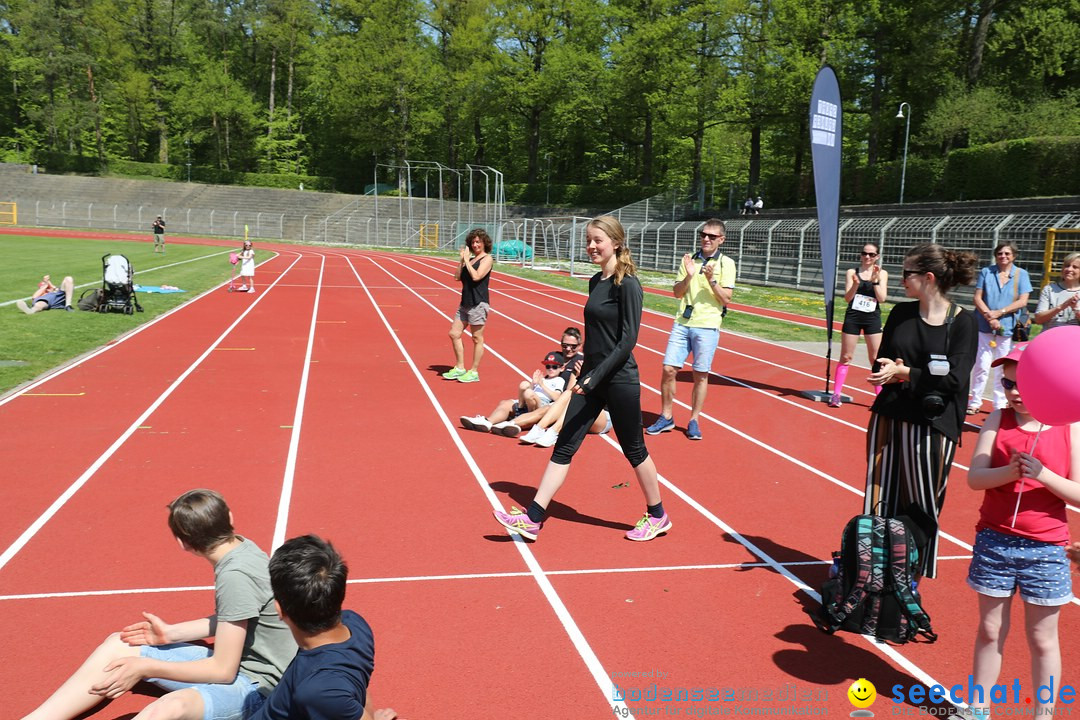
[346,257,629,714]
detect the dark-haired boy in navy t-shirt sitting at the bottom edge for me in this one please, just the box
[252,535,397,720]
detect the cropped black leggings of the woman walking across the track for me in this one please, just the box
[551,383,649,467]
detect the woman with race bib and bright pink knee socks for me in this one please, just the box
[828,243,889,407]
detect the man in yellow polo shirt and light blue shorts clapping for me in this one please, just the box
[645,218,735,440]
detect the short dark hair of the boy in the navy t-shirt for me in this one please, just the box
[270,535,349,635]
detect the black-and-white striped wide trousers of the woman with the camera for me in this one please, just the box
[863,412,956,578]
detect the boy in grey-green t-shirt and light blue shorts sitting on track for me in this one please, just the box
[26,490,296,720]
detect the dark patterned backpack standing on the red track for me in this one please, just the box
[814,515,937,643]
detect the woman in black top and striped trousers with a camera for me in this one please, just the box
[863,244,978,578]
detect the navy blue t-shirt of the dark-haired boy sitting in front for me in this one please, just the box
[252,610,375,720]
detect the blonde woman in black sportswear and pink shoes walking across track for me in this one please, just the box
[495,215,672,542]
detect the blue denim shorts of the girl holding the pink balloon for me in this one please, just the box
[968,528,1072,607]
